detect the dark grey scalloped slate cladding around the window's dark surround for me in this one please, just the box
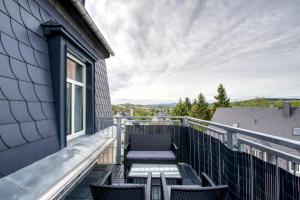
[0,0,111,177]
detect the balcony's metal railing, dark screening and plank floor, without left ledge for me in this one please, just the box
[66,117,300,199]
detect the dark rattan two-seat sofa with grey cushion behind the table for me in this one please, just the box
[124,133,177,173]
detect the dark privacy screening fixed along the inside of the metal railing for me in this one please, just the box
[125,125,300,200]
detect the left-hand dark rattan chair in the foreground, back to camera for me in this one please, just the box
[90,172,151,200]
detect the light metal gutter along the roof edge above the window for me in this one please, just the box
[71,0,115,56]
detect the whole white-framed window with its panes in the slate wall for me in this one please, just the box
[66,54,85,140]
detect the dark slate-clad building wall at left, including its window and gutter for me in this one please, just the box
[0,0,113,178]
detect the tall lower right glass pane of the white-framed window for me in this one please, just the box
[74,85,83,132]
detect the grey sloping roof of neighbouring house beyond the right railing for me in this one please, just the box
[212,108,300,141]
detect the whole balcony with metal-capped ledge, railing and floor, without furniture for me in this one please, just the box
[0,116,300,200]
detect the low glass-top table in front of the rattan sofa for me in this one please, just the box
[127,164,182,183]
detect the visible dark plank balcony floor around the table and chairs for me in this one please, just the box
[66,164,200,200]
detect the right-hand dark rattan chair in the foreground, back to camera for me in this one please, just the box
[161,173,228,200]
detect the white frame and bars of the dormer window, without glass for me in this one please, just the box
[66,53,86,141]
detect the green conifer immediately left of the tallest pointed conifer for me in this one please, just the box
[191,93,211,120]
